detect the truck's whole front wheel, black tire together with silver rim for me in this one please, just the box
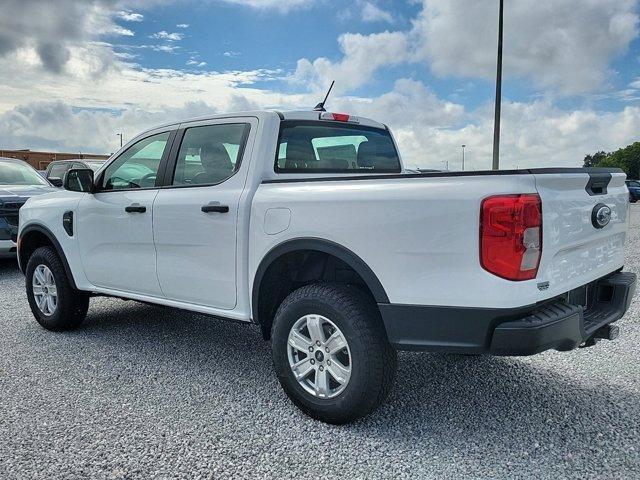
[25,247,89,331]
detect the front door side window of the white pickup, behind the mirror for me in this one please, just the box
[101,132,169,190]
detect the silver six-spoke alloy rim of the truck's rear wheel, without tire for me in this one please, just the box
[287,315,351,398]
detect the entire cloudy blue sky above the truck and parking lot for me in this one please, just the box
[0,0,640,170]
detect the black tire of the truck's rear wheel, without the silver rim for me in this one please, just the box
[272,283,397,424]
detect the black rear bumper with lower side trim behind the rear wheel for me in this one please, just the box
[379,272,636,355]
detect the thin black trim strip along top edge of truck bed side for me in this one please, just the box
[262,168,622,184]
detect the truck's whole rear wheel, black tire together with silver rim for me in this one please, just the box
[272,283,397,424]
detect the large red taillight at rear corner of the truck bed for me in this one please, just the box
[480,194,542,280]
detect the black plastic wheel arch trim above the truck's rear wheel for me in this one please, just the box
[251,238,389,322]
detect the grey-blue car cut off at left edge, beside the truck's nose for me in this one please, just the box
[0,157,55,258]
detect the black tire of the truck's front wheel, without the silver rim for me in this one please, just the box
[25,247,89,332]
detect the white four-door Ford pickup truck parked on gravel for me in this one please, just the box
[18,111,636,423]
